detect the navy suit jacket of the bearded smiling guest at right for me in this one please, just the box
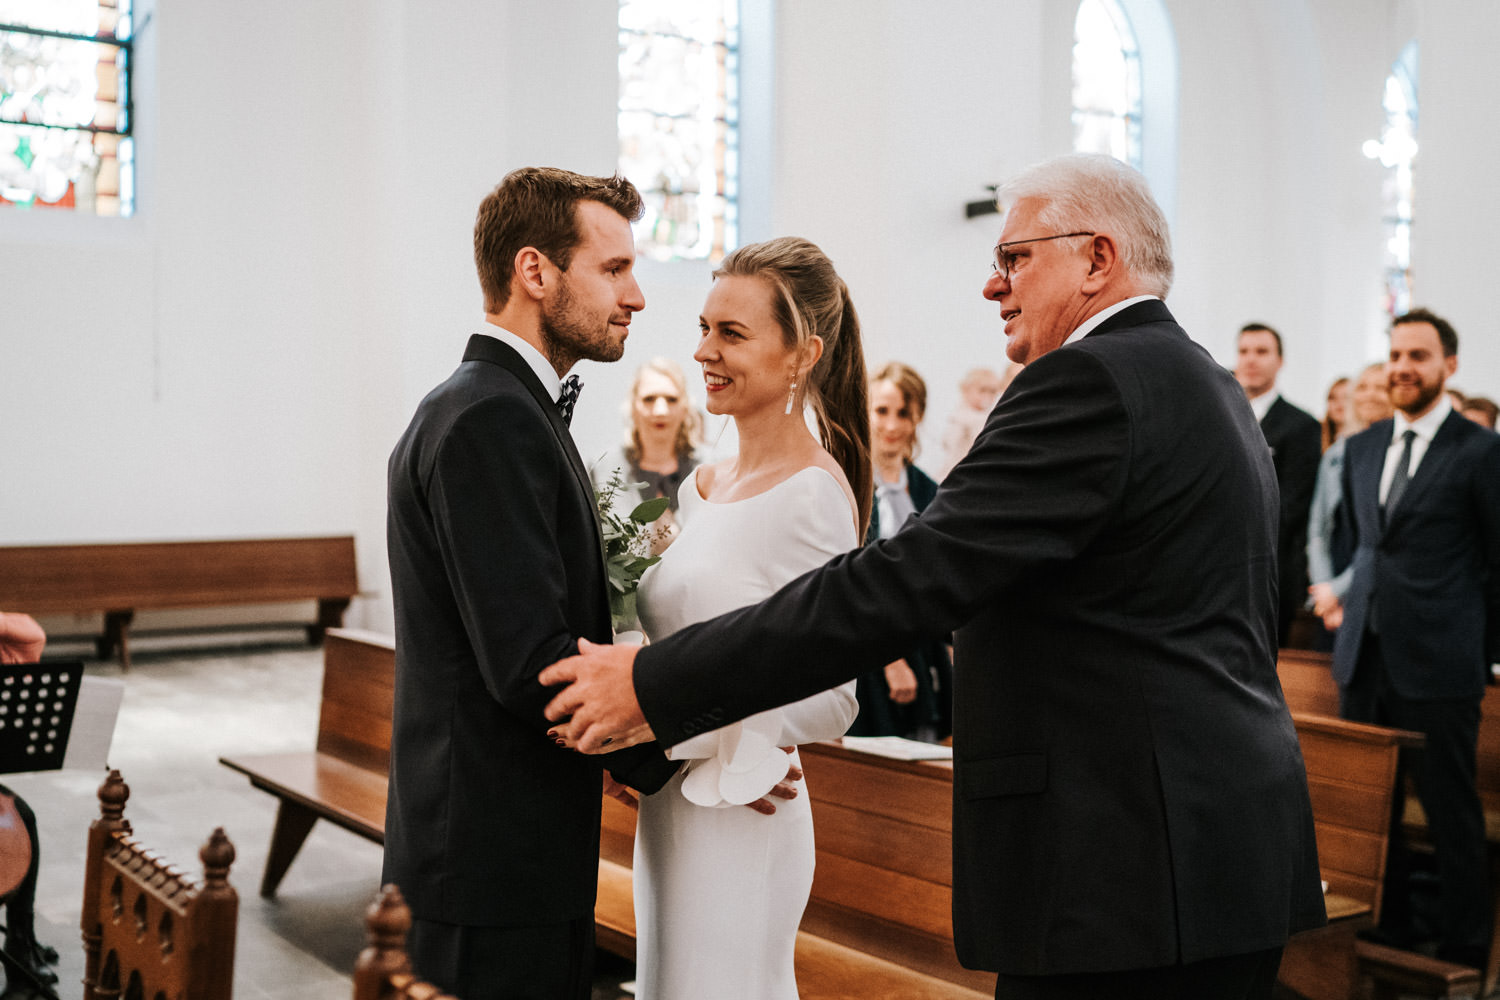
[1334,412,1500,699]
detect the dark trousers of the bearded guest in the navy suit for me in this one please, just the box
[1340,634,1490,966]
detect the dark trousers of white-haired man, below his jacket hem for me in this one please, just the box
[995,947,1281,1000]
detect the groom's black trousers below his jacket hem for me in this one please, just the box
[407,913,594,1000]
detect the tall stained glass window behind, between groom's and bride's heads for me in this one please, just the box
[620,0,740,261]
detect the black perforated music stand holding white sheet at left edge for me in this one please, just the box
[0,660,125,774]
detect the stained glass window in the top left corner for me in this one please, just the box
[0,0,135,216]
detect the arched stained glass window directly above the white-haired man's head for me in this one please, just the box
[1073,0,1142,169]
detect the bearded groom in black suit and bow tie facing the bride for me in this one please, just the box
[383,168,675,1000]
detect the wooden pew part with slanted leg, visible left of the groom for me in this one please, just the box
[219,628,396,897]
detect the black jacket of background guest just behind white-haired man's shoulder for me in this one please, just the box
[1260,397,1323,640]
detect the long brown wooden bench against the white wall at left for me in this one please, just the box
[0,535,359,669]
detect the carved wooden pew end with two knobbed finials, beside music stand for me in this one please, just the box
[81,771,240,1000]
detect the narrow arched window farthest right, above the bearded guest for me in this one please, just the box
[1365,39,1418,316]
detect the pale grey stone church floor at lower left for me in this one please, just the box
[0,633,633,1000]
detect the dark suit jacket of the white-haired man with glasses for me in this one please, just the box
[635,301,1323,975]
